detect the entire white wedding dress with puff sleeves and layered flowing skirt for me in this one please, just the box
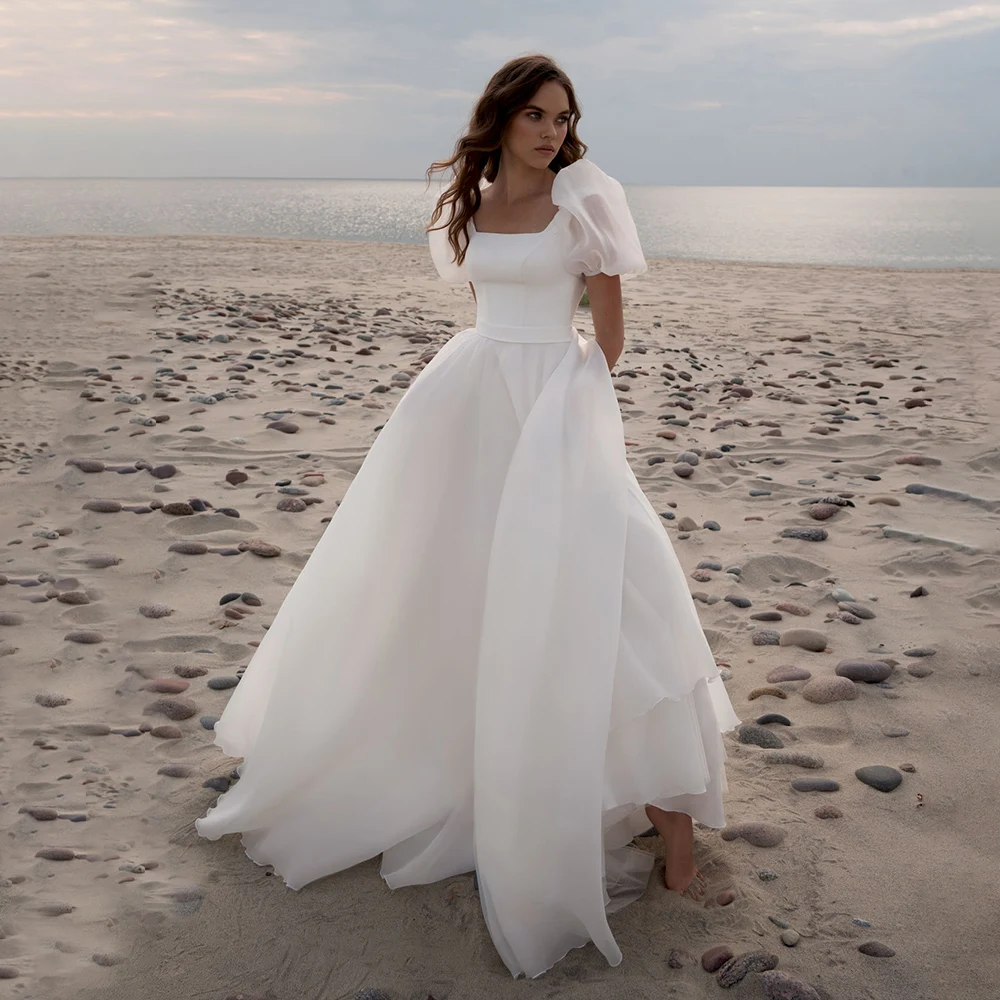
[196,160,740,977]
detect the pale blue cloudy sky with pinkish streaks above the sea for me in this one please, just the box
[0,0,1000,186]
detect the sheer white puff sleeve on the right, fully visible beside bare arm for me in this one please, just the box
[551,159,647,281]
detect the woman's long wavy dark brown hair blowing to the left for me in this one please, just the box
[425,54,587,265]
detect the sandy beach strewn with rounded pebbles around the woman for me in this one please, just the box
[0,237,1000,1000]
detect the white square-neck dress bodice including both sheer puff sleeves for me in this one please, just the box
[428,160,646,342]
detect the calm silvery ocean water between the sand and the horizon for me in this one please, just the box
[0,178,1000,269]
